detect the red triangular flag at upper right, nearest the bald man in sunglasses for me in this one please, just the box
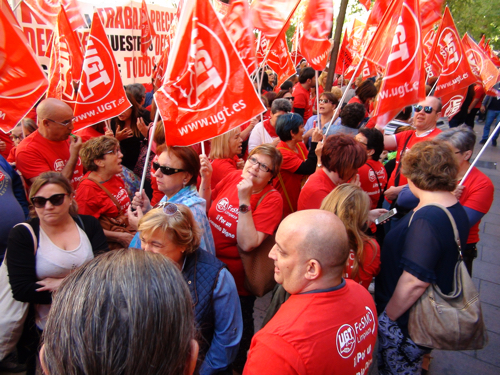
[430,7,476,98]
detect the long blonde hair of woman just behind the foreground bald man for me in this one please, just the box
[320,184,370,279]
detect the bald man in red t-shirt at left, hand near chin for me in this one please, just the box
[16,98,83,189]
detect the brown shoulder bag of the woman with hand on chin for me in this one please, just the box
[237,189,276,297]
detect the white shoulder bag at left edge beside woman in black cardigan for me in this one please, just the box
[0,223,38,361]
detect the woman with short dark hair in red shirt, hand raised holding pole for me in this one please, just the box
[273,113,323,217]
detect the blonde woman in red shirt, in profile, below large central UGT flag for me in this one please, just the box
[209,127,244,187]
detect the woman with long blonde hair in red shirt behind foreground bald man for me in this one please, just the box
[321,184,380,289]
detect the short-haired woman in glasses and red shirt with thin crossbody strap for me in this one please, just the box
[76,136,135,248]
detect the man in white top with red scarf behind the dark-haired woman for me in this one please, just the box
[248,99,292,152]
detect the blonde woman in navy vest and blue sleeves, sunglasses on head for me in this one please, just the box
[139,206,243,375]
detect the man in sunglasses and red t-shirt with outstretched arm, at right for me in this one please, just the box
[377,96,443,203]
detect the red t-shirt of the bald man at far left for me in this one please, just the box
[16,130,83,189]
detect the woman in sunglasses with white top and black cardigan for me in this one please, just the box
[6,172,109,374]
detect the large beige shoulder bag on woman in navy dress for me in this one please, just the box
[408,204,488,350]
